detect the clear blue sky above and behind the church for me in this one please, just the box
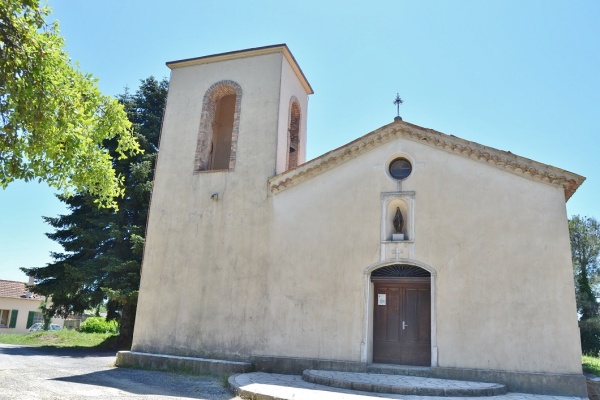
[0,0,600,280]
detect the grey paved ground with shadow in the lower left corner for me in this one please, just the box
[0,344,239,400]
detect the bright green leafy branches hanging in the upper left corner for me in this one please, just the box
[0,0,140,207]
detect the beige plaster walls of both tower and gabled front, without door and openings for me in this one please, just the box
[133,49,581,373]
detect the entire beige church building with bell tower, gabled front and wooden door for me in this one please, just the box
[127,45,585,395]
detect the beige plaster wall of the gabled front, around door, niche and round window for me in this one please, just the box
[264,140,581,373]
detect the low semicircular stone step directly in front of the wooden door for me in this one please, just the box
[302,369,507,397]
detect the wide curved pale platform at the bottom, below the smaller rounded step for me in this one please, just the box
[229,372,585,400]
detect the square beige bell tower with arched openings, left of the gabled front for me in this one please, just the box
[134,44,313,354]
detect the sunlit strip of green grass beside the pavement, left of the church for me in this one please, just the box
[0,330,117,349]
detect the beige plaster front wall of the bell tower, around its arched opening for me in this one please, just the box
[134,50,306,358]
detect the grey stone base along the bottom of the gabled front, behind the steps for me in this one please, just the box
[251,356,588,400]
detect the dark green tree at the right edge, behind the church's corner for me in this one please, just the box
[569,215,600,321]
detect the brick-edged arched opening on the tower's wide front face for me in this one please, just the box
[195,81,242,172]
